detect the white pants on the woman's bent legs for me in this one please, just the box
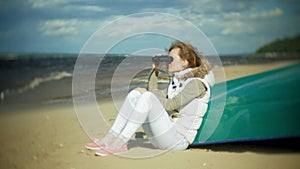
[110,90,189,150]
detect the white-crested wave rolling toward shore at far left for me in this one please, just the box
[0,71,72,100]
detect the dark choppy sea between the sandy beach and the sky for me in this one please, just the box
[0,54,296,106]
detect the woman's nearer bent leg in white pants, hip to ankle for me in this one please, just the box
[120,92,188,150]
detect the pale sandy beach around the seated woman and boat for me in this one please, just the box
[0,61,300,169]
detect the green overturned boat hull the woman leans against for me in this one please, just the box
[193,64,300,145]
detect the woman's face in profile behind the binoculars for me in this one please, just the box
[168,48,188,73]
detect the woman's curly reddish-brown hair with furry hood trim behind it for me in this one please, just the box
[168,41,211,78]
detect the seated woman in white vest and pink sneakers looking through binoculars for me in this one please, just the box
[85,41,214,156]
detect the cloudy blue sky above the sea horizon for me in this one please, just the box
[0,0,300,55]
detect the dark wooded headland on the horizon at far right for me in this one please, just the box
[256,35,300,54]
